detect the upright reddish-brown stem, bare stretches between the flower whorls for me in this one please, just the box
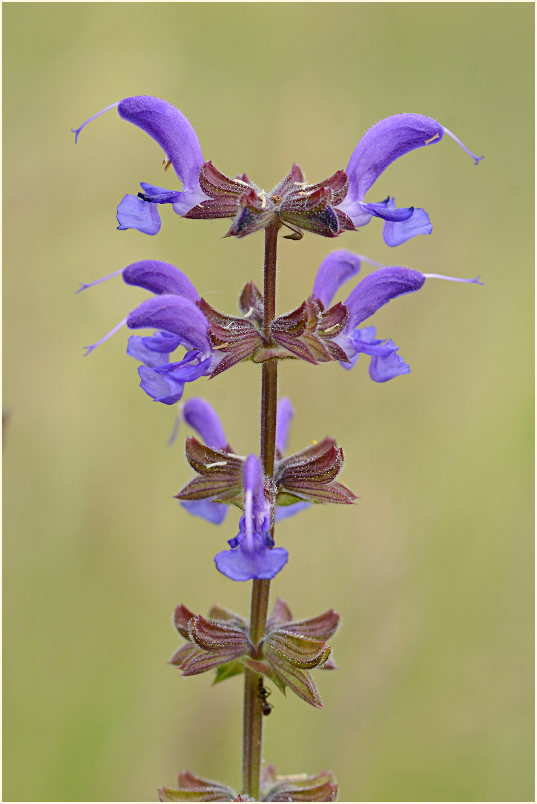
[242,224,280,801]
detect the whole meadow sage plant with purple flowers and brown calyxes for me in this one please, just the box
[74,96,481,801]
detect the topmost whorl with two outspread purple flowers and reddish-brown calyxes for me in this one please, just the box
[73,95,482,246]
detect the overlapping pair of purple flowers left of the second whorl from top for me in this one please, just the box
[80,260,218,405]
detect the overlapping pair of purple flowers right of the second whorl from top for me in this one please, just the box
[313,250,483,382]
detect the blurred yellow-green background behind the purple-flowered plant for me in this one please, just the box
[3,3,534,801]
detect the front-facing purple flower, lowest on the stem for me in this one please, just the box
[214,455,288,581]
